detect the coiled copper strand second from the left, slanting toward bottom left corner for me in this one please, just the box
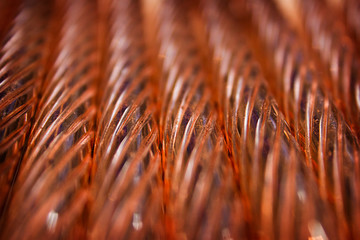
[4,0,99,239]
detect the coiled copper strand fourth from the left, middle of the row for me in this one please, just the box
[158,1,246,239]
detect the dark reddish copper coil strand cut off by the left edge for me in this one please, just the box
[0,1,50,219]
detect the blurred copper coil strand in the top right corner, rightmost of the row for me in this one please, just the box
[300,0,360,137]
